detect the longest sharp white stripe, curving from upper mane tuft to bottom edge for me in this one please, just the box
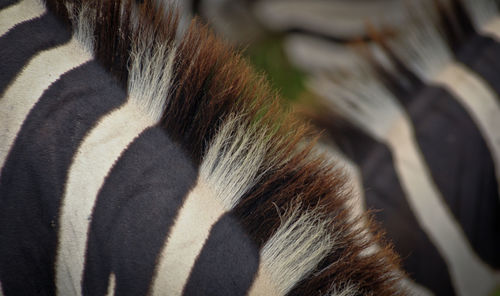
[56,99,154,295]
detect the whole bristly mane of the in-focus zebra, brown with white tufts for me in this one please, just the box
[46,0,405,295]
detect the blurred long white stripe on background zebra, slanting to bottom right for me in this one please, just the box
[386,115,494,295]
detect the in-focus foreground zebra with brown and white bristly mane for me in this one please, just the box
[0,0,409,296]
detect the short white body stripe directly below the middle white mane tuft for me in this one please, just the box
[152,179,226,295]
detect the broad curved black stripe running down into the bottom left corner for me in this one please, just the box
[0,61,125,295]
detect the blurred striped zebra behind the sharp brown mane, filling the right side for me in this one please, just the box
[183,0,500,295]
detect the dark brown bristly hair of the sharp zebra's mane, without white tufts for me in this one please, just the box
[47,0,406,295]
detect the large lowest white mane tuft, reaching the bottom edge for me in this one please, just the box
[248,206,335,296]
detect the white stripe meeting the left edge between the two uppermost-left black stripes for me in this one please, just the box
[0,39,92,172]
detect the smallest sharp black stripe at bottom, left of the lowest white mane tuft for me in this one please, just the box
[183,214,259,296]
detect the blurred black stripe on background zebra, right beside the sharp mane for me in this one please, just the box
[337,127,454,295]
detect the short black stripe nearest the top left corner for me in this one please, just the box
[0,14,71,96]
